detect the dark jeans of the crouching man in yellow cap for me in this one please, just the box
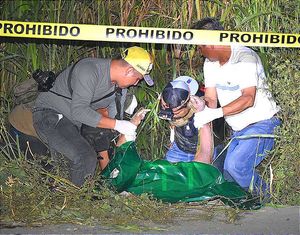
[33,108,97,186]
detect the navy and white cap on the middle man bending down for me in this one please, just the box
[161,76,199,109]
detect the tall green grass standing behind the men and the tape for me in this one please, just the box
[0,0,300,204]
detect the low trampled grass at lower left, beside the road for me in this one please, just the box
[0,150,179,229]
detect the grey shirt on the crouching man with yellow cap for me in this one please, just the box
[35,58,127,127]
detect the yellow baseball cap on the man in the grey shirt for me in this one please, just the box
[122,46,154,86]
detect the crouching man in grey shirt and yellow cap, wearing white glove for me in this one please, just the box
[33,47,153,186]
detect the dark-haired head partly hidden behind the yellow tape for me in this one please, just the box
[192,17,228,61]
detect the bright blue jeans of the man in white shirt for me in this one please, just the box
[224,117,280,194]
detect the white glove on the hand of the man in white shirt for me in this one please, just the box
[194,107,224,129]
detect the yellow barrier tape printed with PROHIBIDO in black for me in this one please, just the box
[0,21,300,48]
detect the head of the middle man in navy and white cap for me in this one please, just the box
[159,76,198,120]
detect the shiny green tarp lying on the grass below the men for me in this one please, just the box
[101,142,256,208]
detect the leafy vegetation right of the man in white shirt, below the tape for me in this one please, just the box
[265,49,300,205]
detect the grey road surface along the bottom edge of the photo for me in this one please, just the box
[0,206,300,234]
